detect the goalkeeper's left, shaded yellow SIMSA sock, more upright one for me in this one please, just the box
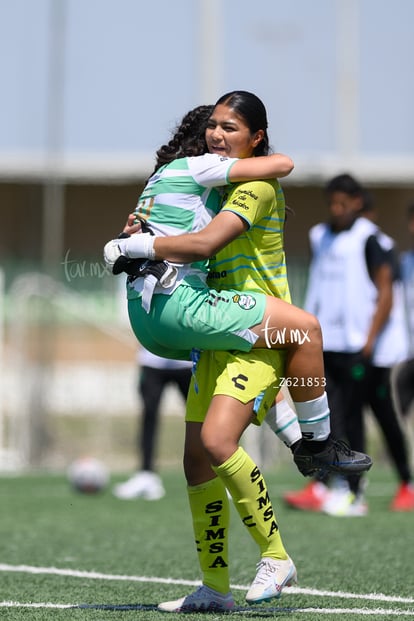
[187,477,230,593]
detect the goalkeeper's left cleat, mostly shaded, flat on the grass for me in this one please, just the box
[158,585,234,612]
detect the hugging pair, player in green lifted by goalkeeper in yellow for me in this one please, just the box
[105,91,371,611]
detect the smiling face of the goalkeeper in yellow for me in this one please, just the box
[206,104,263,158]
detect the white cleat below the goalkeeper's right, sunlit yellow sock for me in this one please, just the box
[246,557,297,604]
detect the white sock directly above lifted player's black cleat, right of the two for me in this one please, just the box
[293,392,331,440]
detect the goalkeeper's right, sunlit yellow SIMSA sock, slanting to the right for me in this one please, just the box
[213,447,288,560]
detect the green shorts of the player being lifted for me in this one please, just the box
[128,281,266,360]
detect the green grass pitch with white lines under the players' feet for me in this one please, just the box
[0,465,414,621]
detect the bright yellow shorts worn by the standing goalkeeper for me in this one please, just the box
[185,349,286,425]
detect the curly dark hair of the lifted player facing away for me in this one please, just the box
[152,106,214,174]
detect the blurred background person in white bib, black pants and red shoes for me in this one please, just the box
[285,175,414,516]
